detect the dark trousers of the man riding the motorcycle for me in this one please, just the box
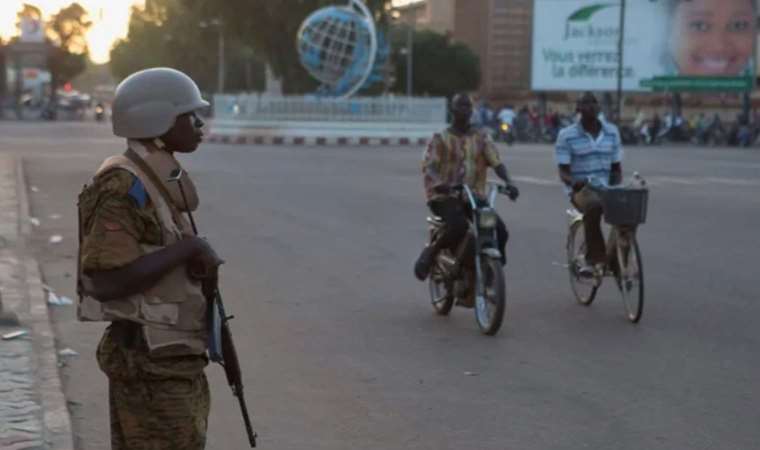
[428,198,509,264]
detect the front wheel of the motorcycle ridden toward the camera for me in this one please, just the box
[475,257,507,336]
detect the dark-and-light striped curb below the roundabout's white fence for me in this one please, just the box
[207,134,429,147]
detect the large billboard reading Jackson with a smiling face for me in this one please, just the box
[531,0,757,92]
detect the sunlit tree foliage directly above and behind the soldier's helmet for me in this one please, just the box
[110,0,264,92]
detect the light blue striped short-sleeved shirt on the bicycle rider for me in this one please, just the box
[555,121,623,192]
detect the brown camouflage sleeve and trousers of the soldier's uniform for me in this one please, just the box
[80,169,210,450]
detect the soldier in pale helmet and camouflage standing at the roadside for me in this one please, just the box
[78,68,222,450]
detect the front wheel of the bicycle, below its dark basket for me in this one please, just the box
[616,234,644,323]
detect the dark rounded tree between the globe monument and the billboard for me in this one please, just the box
[391,29,481,97]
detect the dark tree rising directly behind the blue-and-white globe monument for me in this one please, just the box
[190,0,390,93]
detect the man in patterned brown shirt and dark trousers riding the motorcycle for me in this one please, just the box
[414,94,520,281]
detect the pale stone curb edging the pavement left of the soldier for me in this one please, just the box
[16,158,74,450]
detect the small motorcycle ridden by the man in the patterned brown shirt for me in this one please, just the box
[427,181,515,336]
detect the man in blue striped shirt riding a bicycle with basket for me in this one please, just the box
[556,92,623,277]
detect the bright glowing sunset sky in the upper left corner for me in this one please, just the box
[0,0,144,63]
